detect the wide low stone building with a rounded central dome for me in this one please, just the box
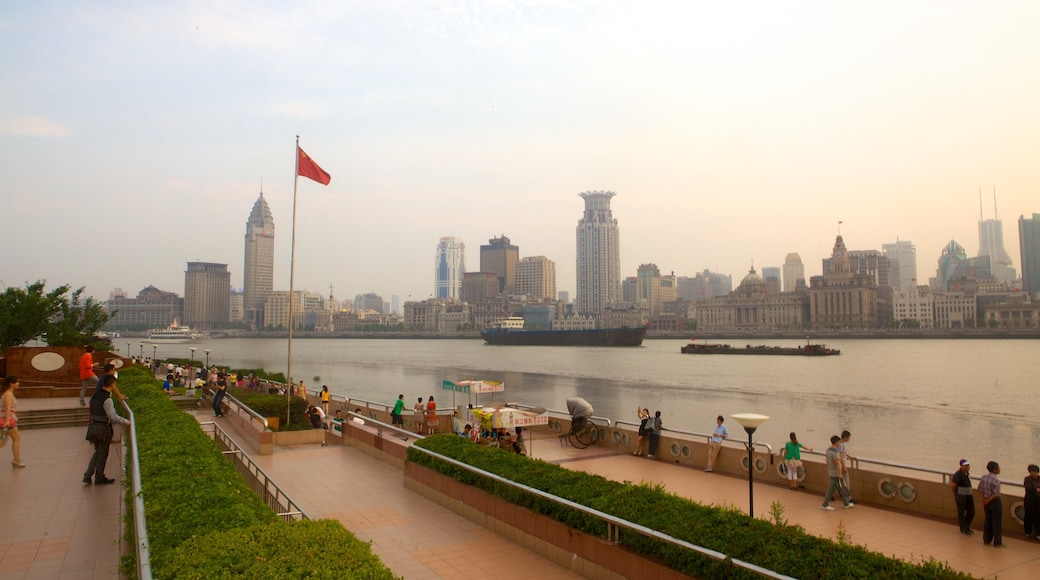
[697,266,809,332]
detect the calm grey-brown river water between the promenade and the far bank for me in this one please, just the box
[158,339,1040,479]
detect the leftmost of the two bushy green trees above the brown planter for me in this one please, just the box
[0,280,68,352]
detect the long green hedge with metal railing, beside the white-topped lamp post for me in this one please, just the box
[408,434,970,579]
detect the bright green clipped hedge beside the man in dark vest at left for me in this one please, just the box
[119,367,395,578]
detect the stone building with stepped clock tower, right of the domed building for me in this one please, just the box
[809,235,878,328]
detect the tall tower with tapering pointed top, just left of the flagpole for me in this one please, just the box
[242,191,275,328]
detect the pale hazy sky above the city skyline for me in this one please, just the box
[0,0,1040,300]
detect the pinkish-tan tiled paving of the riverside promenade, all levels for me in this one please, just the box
[0,399,1040,580]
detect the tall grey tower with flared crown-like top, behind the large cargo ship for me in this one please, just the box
[576,191,621,316]
